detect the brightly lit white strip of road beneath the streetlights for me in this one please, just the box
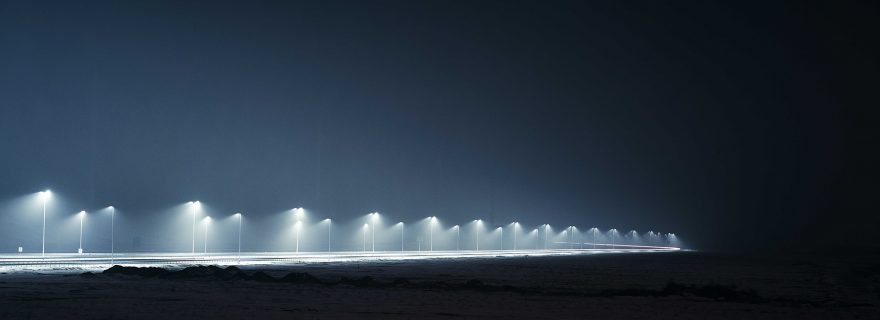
[0,246,679,272]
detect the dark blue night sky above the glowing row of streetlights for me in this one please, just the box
[0,1,880,249]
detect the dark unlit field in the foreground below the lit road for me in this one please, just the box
[0,252,880,320]
